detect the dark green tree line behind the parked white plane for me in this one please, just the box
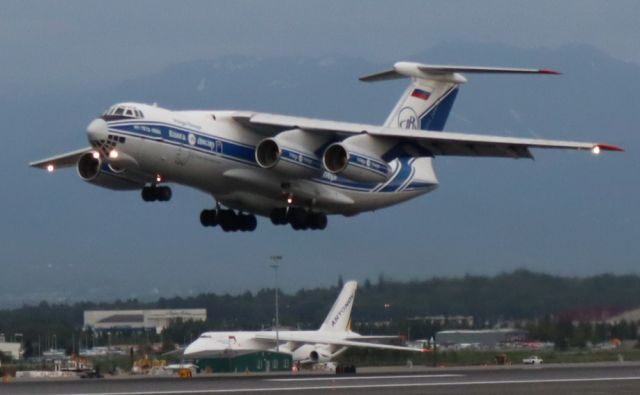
[0,270,640,350]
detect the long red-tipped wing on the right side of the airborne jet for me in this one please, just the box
[234,113,623,158]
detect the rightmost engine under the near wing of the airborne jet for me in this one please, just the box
[322,135,391,182]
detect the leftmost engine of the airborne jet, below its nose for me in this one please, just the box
[76,152,144,191]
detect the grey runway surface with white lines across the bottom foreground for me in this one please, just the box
[5,364,640,395]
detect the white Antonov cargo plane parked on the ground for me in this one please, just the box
[183,281,429,363]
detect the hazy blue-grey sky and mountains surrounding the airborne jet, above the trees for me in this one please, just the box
[0,2,640,306]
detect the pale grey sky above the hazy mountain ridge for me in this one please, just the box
[0,0,640,89]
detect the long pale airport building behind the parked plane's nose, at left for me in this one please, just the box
[84,309,207,334]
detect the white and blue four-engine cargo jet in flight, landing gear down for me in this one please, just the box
[30,62,622,231]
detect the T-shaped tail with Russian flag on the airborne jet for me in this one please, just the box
[360,62,559,131]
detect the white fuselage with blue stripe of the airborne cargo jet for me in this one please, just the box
[94,103,437,215]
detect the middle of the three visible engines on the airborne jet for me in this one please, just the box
[256,129,326,178]
